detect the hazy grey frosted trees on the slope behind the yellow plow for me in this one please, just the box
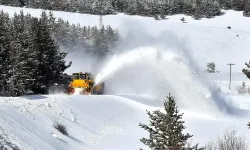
[53,18,119,57]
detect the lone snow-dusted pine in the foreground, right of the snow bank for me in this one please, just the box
[139,94,204,150]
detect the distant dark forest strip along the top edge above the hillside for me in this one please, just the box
[0,0,225,20]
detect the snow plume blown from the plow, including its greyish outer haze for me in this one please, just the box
[91,32,242,115]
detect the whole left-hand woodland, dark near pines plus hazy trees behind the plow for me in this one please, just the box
[0,11,119,96]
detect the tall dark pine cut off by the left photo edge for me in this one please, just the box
[0,11,12,96]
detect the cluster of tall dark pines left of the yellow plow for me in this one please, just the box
[0,12,69,96]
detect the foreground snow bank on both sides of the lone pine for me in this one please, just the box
[0,95,250,150]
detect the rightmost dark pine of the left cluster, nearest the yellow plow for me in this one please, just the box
[31,12,71,93]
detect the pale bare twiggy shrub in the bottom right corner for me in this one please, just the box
[205,129,247,150]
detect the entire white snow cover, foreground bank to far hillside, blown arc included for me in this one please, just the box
[0,6,250,150]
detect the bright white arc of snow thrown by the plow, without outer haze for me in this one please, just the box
[92,44,221,113]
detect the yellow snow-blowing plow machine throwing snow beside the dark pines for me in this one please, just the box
[67,72,104,95]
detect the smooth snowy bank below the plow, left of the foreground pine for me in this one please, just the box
[0,95,148,150]
